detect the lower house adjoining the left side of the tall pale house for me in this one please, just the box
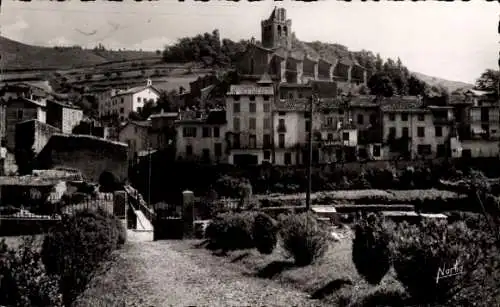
[175,110,227,163]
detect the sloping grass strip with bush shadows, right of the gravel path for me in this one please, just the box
[188,230,401,306]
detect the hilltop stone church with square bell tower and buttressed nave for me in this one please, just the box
[235,7,370,94]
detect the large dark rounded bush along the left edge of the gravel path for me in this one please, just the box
[41,210,125,305]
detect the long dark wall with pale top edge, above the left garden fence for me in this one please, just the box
[37,134,128,182]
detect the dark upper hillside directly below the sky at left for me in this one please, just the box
[0,36,159,71]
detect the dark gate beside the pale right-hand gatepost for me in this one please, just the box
[153,203,184,241]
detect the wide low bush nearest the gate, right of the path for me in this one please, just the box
[206,212,255,251]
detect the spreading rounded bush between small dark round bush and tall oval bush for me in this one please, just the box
[280,213,328,266]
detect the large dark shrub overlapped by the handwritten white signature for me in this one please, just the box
[392,220,471,304]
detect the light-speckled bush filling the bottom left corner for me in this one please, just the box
[0,238,62,306]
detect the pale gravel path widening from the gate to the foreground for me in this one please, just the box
[77,232,322,306]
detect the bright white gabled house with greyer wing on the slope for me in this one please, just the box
[100,79,160,121]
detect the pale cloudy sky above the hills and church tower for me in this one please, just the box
[0,0,500,83]
